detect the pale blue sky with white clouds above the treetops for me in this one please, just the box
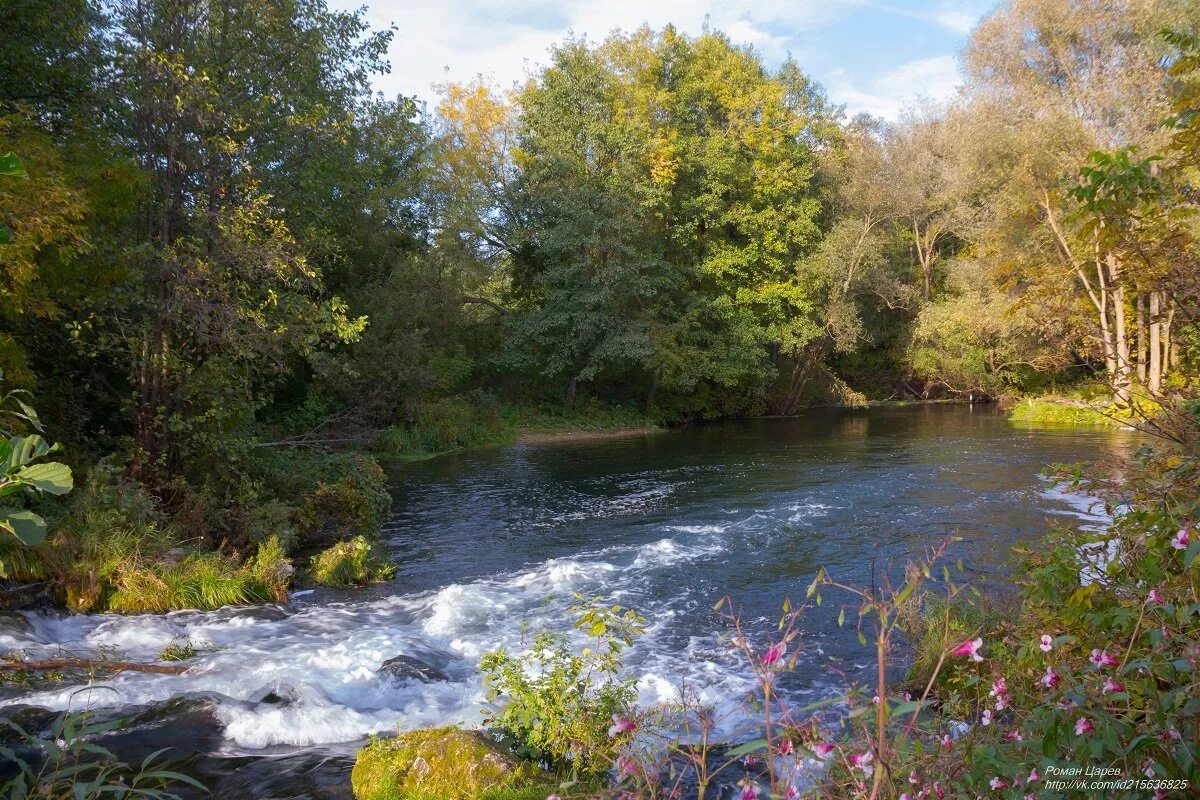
[330,0,995,119]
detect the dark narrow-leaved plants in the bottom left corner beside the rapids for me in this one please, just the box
[0,711,205,800]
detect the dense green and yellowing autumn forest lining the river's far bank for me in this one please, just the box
[0,0,1200,599]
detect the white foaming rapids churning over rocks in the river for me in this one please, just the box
[0,525,749,750]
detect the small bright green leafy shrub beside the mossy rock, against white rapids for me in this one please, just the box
[480,595,644,776]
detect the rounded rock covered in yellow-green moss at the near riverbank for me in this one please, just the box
[350,728,552,800]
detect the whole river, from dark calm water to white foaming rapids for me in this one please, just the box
[0,405,1132,796]
